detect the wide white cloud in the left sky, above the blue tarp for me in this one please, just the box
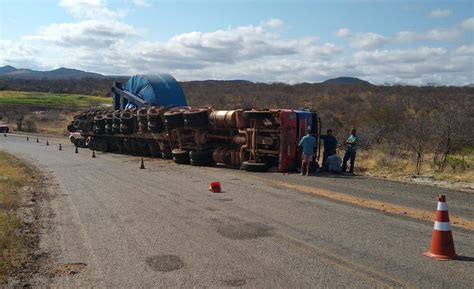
[24,20,137,48]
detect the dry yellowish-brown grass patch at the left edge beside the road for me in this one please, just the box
[0,151,33,285]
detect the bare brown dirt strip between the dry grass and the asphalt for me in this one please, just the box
[6,153,92,287]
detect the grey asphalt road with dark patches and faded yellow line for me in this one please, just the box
[0,134,474,288]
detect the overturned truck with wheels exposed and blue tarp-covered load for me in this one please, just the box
[68,75,320,172]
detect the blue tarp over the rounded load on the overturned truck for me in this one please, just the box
[124,74,187,108]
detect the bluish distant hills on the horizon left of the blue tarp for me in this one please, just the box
[0,65,106,79]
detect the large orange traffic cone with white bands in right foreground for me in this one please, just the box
[423,195,458,260]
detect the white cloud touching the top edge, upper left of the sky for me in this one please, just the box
[59,0,125,19]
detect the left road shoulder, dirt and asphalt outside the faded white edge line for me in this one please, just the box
[9,153,103,287]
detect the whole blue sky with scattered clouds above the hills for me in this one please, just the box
[0,0,474,85]
